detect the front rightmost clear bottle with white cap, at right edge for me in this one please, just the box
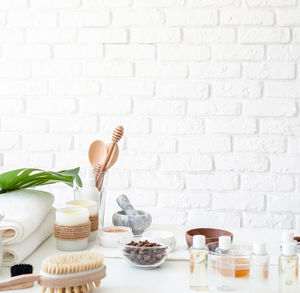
[279,243,298,293]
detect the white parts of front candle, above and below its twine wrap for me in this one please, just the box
[56,207,89,251]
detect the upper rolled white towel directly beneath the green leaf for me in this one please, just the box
[0,189,54,245]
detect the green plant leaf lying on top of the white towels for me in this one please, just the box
[0,168,82,193]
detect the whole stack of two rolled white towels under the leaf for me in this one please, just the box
[0,189,55,266]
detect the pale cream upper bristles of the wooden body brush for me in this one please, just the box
[43,252,103,275]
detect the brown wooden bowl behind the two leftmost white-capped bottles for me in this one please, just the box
[185,228,233,247]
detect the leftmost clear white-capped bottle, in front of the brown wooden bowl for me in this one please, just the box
[190,235,208,291]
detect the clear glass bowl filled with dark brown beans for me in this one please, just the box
[120,240,168,269]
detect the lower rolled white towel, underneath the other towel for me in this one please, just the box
[2,208,55,266]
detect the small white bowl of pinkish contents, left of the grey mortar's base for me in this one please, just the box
[99,226,133,248]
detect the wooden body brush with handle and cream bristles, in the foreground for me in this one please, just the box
[0,252,106,293]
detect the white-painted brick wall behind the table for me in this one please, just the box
[0,0,300,228]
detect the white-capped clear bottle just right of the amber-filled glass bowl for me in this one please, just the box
[250,242,269,293]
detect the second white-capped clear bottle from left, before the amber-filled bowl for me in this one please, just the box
[215,236,235,291]
